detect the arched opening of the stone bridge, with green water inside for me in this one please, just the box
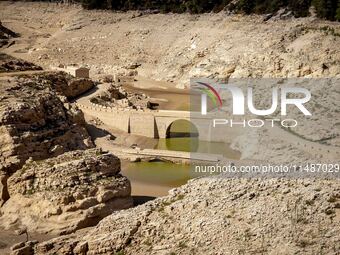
[166,119,199,138]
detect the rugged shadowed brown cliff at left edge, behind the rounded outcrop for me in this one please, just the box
[0,74,93,207]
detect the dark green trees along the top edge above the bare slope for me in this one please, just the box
[79,0,340,20]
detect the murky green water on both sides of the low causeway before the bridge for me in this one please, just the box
[122,137,240,196]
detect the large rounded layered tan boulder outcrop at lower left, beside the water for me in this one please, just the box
[0,149,132,234]
